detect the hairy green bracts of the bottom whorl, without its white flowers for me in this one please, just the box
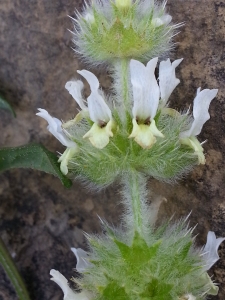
[76,220,210,300]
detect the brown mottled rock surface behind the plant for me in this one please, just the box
[0,0,225,300]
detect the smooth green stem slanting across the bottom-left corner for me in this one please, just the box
[0,238,30,300]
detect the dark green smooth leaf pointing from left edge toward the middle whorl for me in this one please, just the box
[0,144,72,188]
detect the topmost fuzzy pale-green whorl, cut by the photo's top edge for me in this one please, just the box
[74,0,177,64]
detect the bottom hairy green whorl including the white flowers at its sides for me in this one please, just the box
[50,227,225,300]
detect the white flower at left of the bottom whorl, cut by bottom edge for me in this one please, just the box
[50,269,90,300]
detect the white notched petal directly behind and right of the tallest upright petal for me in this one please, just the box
[159,58,183,106]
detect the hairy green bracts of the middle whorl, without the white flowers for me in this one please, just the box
[67,111,197,187]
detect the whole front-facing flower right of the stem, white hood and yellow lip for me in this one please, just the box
[129,58,164,149]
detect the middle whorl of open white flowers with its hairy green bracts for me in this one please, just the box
[37,58,217,184]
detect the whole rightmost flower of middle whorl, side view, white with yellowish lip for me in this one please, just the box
[180,88,218,164]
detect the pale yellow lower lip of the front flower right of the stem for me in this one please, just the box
[129,119,164,149]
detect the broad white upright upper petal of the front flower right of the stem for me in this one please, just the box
[130,57,159,121]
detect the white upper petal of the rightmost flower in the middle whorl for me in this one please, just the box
[180,88,218,138]
